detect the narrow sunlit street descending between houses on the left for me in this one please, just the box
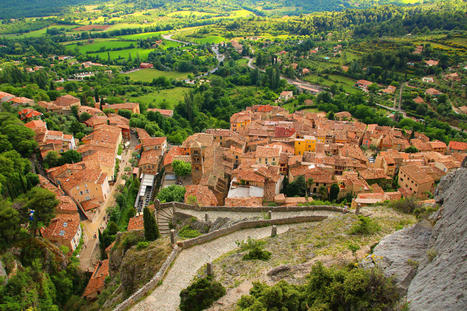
[79,135,138,272]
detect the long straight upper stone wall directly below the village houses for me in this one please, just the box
[159,202,348,213]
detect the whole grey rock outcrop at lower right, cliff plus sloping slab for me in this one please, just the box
[363,167,467,311]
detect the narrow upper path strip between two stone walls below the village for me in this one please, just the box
[176,208,342,221]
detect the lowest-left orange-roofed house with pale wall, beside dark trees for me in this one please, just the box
[41,211,82,251]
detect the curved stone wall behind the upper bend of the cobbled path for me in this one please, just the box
[177,216,327,249]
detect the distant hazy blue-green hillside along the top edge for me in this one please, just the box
[0,0,435,19]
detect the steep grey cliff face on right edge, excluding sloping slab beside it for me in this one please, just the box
[407,168,467,310]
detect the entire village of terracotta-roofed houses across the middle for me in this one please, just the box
[0,84,467,299]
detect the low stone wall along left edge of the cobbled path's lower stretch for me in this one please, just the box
[114,246,182,311]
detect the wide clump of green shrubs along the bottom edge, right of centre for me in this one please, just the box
[237,262,399,311]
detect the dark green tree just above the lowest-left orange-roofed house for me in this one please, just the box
[23,187,59,235]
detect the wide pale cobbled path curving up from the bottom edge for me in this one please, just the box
[130,225,297,311]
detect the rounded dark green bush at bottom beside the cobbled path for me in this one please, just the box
[180,277,225,311]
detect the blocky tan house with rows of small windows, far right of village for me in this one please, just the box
[398,165,435,199]
